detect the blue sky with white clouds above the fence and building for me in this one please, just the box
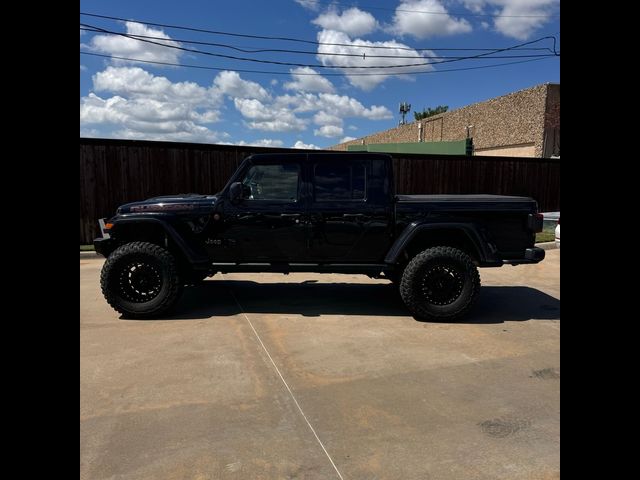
[80,0,560,148]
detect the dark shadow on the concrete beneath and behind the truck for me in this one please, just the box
[126,280,560,324]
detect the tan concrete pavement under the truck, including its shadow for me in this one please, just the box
[80,250,560,480]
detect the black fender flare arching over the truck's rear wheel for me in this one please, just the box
[384,221,502,266]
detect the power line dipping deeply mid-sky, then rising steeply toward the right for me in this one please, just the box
[80,23,556,70]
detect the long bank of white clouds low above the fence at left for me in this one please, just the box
[80,62,393,146]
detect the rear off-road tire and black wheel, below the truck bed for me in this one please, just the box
[400,247,480,322]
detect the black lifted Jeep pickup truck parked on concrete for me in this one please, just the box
[94,153,545,321]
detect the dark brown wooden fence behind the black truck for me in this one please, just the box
[80,138,560,244]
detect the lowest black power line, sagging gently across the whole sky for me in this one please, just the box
[80,51,555,77]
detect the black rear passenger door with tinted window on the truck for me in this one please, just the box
[307,154,391,263]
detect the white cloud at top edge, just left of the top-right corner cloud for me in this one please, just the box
[389,0,472,39]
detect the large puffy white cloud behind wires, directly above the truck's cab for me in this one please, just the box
[316,30,435,90]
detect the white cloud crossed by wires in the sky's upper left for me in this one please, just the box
[90,22,181,63]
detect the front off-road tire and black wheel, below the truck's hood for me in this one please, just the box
[100,242,182,318]
